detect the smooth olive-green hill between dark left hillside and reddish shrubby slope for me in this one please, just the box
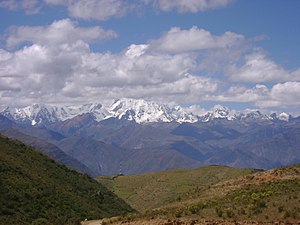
[97,166,253,212]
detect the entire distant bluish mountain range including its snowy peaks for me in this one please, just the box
[0,99,300,176]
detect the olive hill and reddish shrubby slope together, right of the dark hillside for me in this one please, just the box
[98,164,300,222]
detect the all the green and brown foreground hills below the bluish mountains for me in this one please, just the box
[0,131,300,225]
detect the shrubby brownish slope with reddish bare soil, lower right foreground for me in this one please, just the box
[149,164,300,222]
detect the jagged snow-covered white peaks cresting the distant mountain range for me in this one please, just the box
[0,98,290,125]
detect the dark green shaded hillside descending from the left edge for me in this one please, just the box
[0,136,132,225]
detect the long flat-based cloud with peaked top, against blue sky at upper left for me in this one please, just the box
[6,19,117,47]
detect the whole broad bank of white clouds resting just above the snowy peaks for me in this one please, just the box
[0,19,300,111]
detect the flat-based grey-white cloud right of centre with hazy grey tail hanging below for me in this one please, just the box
[149,26,251,74]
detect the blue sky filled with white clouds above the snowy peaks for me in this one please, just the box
[0,0,300,115]
